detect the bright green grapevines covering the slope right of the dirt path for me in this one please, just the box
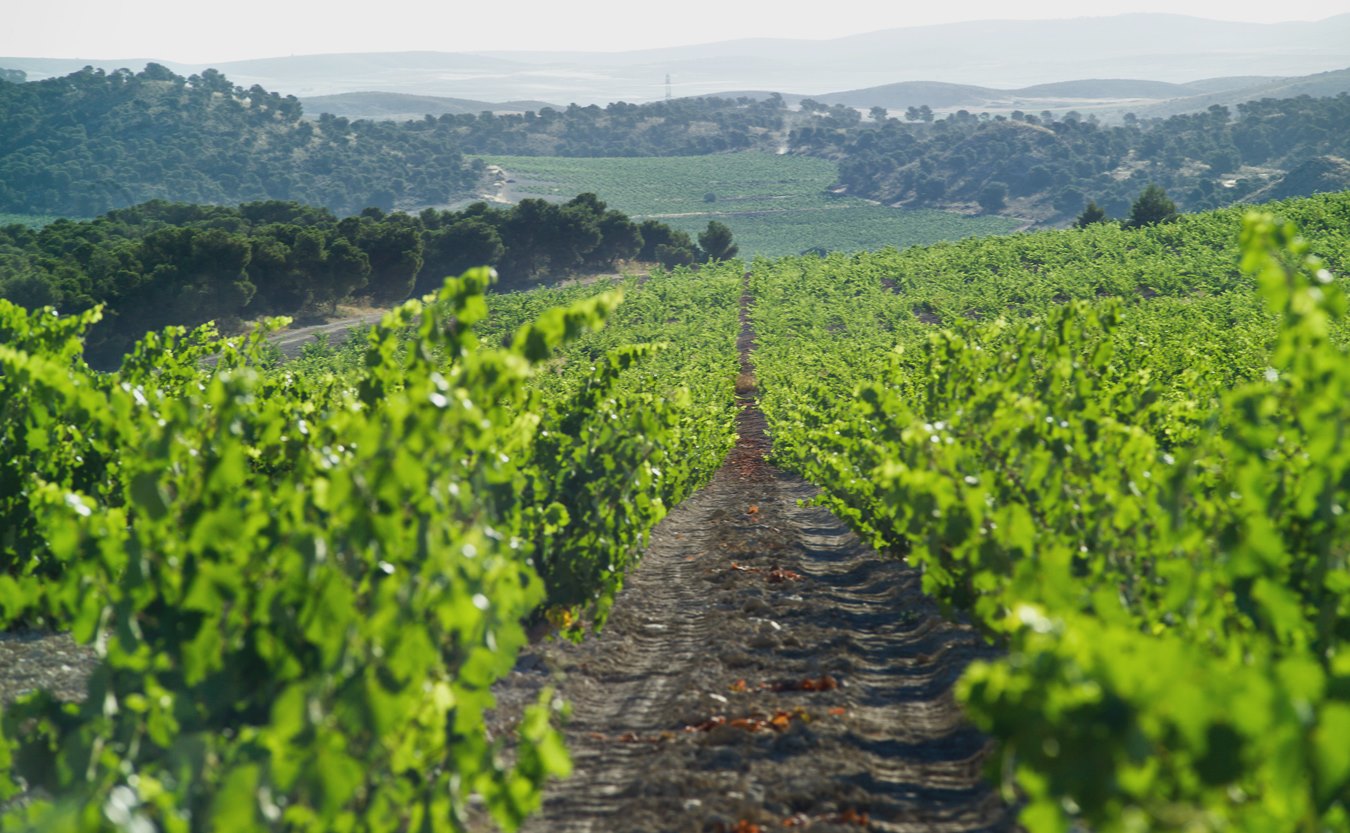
[752,194,1350,833]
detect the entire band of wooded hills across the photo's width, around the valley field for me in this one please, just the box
[0,65,1350,230]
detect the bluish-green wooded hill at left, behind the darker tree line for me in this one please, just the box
[0,63,475,216]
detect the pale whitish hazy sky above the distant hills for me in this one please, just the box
[0,0,1350,63]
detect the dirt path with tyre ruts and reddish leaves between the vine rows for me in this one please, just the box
[488,278,1013,833]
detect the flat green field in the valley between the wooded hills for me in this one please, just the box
[483,153,1019,257]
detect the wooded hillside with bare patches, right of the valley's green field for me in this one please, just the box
[810,93,1350,219]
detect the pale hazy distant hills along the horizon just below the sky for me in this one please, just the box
[0,14,1350,105]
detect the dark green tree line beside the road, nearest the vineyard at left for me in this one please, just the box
[0,194,718,365]
